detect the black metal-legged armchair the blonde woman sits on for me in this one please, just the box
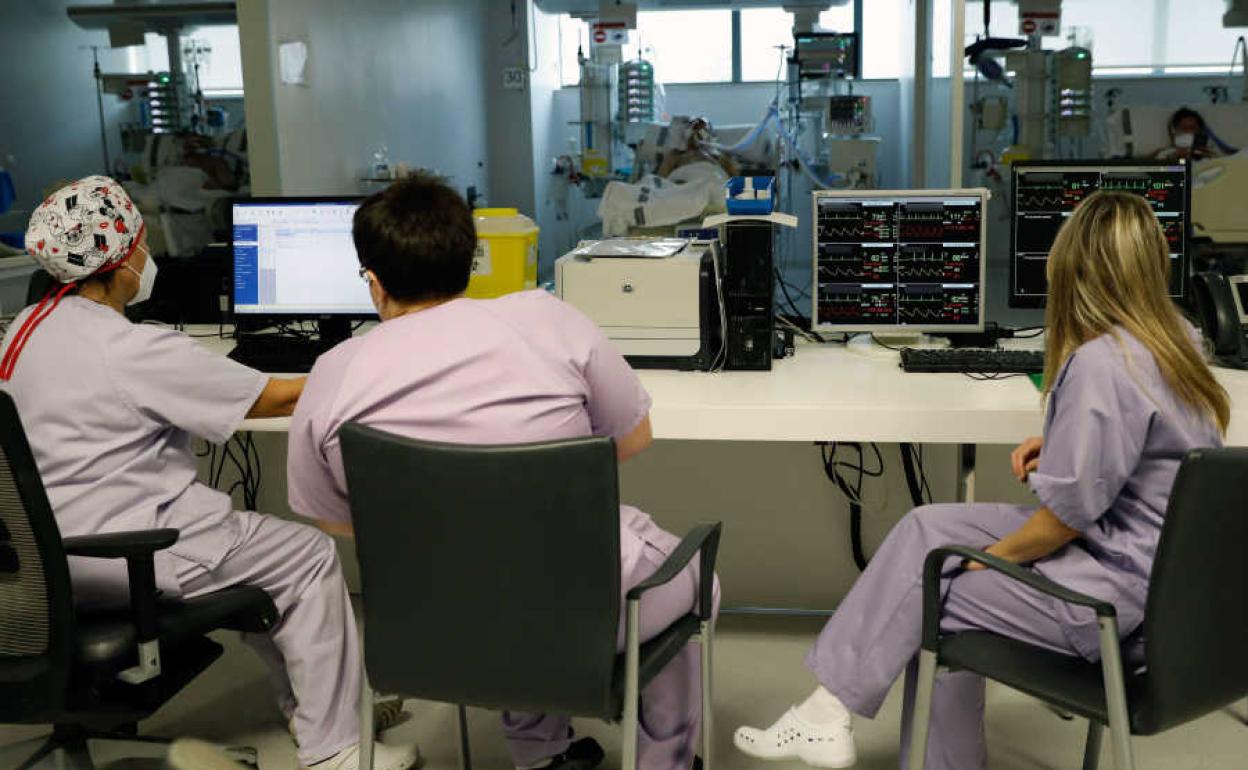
[909,449,1248,770]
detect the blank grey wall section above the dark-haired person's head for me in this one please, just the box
[240,0,488,195]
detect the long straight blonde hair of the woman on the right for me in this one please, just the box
[1045,191,1231,433]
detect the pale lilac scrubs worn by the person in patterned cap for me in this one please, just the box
[0,296,359,764]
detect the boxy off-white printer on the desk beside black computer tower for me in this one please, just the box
[555,240,725,371]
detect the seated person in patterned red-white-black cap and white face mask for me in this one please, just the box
[0,176,417,770]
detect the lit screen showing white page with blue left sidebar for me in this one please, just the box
[232,198,377,316]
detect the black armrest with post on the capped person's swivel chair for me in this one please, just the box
[61,529,178,643]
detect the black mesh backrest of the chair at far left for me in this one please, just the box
[0,391,74,719]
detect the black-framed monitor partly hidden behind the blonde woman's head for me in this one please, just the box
[1010,161,1192,307]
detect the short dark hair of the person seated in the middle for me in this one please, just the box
[352,172,477,302]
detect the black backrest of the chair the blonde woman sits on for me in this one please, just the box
[1132,449,1248,735]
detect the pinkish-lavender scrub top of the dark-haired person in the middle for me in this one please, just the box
[287,291,670,570]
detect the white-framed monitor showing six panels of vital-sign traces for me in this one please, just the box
[811,190,988,333]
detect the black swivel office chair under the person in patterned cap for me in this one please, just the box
[0,391,277,770]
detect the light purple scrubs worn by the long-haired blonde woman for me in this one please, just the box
[806,331,1222,770]
